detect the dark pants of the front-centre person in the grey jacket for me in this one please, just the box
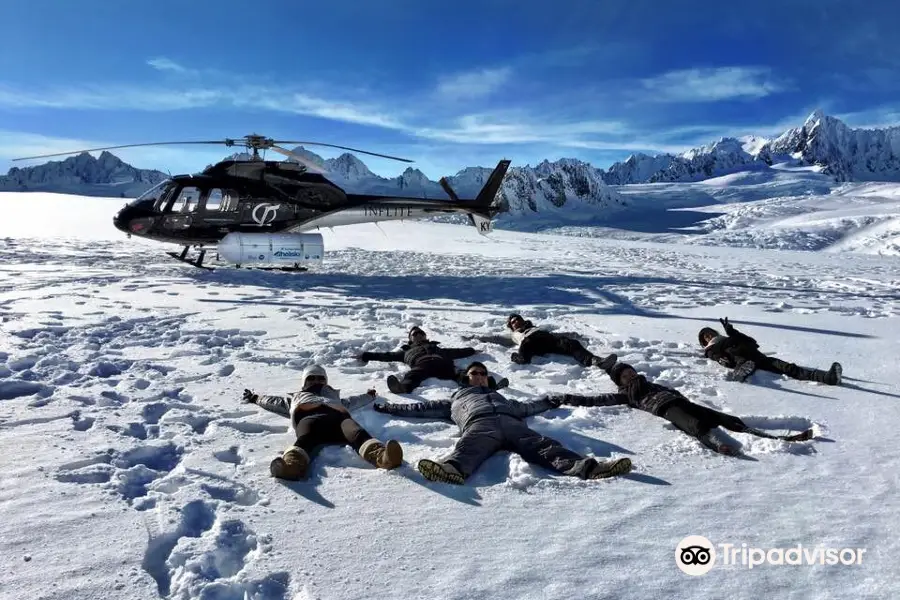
[443,415,585,477]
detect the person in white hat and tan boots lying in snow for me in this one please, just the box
[242,365,403,481]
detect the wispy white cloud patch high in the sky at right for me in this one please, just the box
[640,67,786,102]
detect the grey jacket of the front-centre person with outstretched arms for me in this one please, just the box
[378,386,558,431]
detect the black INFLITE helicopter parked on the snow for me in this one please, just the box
[13,133,510,271]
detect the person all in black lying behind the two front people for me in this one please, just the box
[357,327,509,394]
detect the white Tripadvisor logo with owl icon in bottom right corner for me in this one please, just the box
[675,535,866,575]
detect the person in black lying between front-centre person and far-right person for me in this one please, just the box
[542,363,813,456]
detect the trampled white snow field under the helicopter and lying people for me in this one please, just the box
[0,190,900,600]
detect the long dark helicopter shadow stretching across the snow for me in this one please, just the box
[190,269,884,338]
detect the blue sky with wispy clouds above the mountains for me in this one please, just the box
[0,0,900,179]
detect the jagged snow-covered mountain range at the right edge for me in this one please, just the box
[603,110,900,185]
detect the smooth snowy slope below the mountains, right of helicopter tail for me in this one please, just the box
[548,165,900,256]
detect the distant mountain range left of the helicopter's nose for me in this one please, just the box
[0,151,167,198]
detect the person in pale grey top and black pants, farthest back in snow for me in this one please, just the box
[473,313,617,369]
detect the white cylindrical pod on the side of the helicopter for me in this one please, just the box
[217,231,325,265]
